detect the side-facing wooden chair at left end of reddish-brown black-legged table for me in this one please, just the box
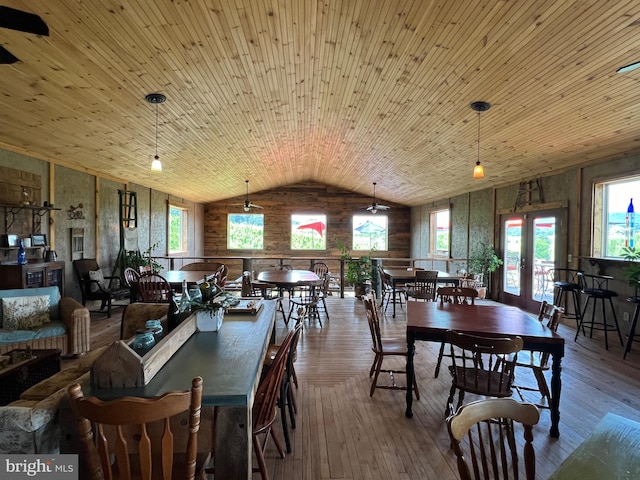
[363,294,420,400]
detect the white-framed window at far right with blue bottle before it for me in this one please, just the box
[592,177,640,258]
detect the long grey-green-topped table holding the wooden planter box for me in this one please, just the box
[83,300,276,480]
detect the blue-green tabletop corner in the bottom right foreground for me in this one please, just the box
[549,413,640,480]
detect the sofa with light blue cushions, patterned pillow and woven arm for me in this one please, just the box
[0,286,91,356]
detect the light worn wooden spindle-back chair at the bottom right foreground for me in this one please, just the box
[447,398,540,480]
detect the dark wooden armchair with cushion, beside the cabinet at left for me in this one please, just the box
[73,258,130,317]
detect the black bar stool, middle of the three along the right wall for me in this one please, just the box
[573,272,624,350]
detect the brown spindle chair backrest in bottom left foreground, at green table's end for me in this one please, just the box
[68,377,202,480]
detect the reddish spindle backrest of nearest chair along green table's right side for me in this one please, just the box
[253,323,302,433]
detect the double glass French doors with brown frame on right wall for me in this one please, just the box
[500,209,563,312]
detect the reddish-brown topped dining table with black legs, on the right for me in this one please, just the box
[405,302,564,437]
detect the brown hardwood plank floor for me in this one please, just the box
[77,297,640,480]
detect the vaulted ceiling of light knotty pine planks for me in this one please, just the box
[0,0,640,205]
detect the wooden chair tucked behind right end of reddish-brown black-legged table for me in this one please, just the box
[513,302,564,408]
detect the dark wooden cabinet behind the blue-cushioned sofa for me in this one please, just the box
[0,262,64,296]
